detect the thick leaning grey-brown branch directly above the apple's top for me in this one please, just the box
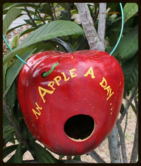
[76,3,105,51]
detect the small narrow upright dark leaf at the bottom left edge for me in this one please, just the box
[13,143,22,163]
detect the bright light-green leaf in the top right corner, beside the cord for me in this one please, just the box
[123,3,138,22]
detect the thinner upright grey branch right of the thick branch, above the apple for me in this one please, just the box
[98,3,106,44]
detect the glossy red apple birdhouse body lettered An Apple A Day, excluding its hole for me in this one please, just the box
[17,50,124,155]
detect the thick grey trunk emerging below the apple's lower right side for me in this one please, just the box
[108,124,121,163]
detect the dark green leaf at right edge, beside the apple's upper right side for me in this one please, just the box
[122,54,138,93]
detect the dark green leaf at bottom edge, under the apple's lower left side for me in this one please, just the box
[29,141,58,163]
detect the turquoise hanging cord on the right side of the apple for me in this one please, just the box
[110,3,124,55]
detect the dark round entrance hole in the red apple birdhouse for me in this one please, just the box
[64,114,94,141]
